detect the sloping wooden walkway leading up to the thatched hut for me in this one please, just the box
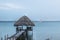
[8,31,26,40]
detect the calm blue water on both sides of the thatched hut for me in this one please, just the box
[0,21,60,40]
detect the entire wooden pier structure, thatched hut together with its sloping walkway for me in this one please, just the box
[1,16,35,40]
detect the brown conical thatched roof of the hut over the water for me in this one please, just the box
[14,16,35,26]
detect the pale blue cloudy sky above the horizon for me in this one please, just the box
[0,0,60,21]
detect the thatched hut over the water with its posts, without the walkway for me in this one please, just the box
[14,16,35,40]
